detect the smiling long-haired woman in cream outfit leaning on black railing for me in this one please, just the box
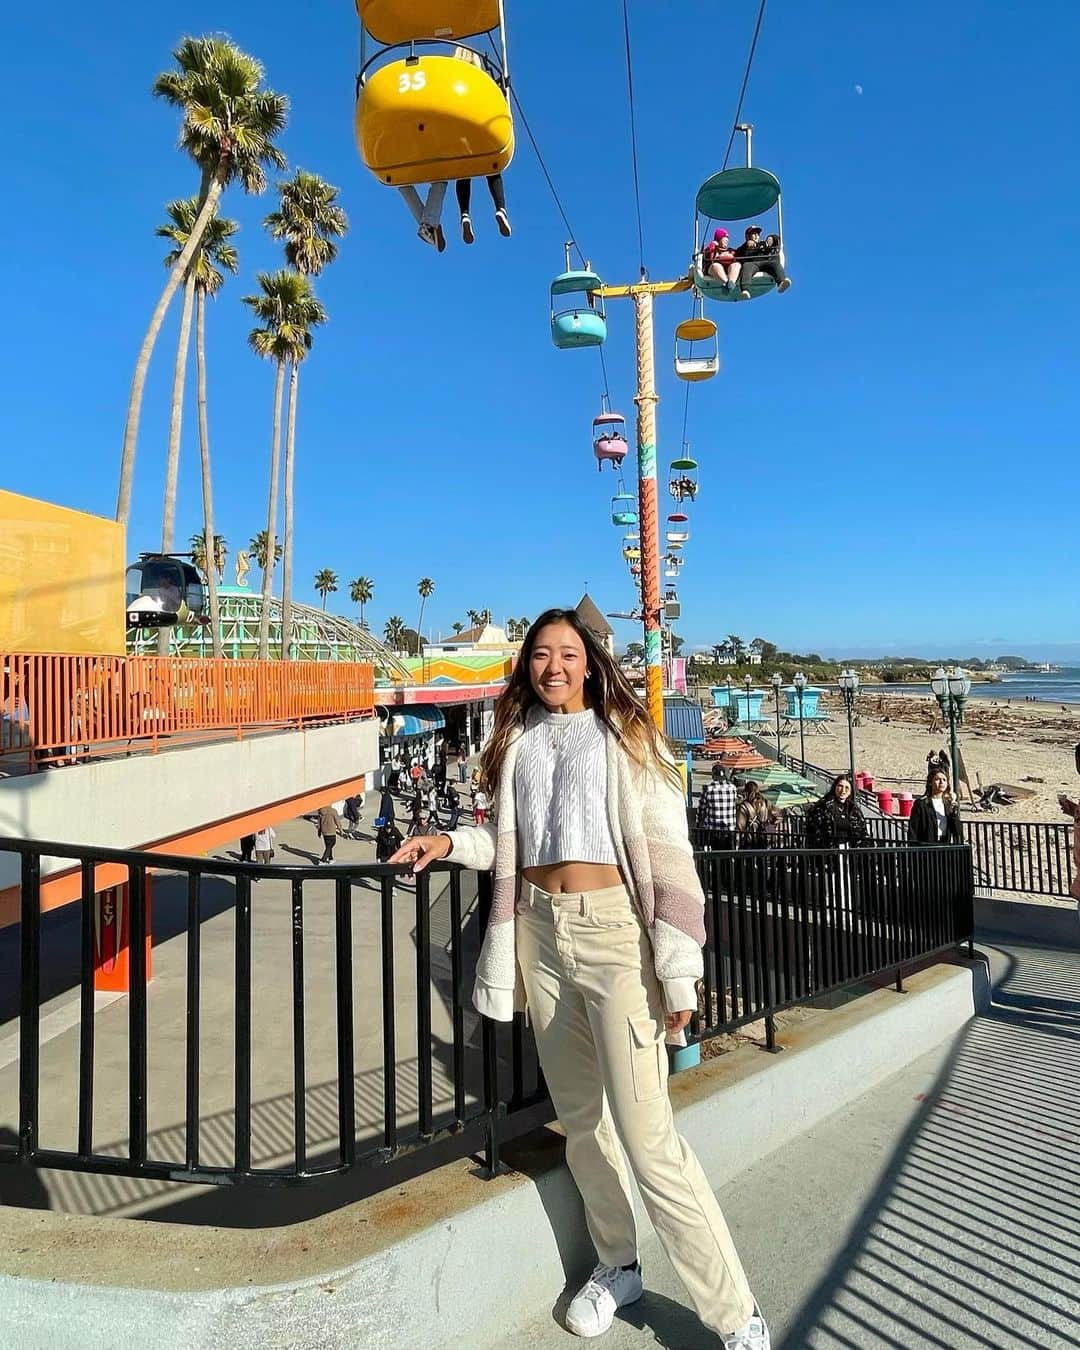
[392,609,770,1350]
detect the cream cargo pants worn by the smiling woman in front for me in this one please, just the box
[516,882,753,1332]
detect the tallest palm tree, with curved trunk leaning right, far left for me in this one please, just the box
[116,38,289,522]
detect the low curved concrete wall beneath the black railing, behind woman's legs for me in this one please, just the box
[0,963,988,1350]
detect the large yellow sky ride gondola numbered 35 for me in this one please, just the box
[355,0,514,188]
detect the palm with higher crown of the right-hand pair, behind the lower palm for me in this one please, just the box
[263,169,348,655]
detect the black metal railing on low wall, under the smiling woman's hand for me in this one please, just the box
[0,840,973,1185]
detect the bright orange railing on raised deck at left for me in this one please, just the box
[0,652,375,763]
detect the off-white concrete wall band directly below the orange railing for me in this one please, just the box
[0,718,379,891]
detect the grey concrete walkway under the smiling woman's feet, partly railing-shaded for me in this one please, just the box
[498,934,1080,1350]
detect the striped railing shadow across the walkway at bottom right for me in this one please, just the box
[777,938,1080,1350]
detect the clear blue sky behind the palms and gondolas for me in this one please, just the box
[0,0,1080,656]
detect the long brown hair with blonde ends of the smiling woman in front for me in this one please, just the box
[481,609,682,797]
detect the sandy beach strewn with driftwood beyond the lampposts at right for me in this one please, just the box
[763,691,1080,822]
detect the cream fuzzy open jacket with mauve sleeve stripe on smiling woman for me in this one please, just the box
[450,732,705,1022]
